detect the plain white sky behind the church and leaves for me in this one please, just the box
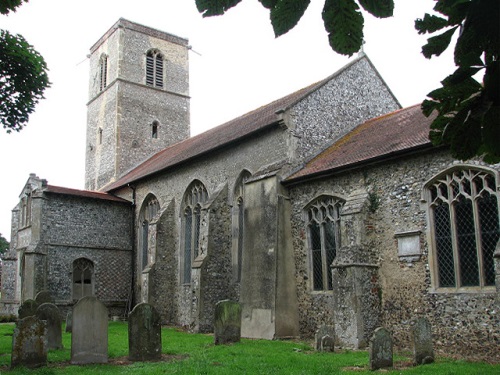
[0,0,454,240]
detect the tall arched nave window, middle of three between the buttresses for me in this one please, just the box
[182,181,208,283]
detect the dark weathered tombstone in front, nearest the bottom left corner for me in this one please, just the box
[10,315,47,368]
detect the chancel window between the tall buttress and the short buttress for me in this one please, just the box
[307,197,343,291]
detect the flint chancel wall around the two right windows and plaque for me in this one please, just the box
[290,150,500,359]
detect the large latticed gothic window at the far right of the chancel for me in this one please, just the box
[427,168,500,290]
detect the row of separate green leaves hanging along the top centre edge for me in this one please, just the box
[196,0,394,56]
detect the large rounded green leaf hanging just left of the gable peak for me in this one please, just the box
[322,0,364,56]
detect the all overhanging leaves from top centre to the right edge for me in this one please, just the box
[196,0,500,162]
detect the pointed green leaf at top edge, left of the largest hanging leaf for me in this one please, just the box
[271,0,310,37]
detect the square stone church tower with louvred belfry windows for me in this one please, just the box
[85,19,190,190]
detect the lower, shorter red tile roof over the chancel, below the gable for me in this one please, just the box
[285,104,433,183]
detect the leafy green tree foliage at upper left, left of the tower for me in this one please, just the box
[0,0,50,133]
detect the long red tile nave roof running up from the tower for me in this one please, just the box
[103,56,367,192]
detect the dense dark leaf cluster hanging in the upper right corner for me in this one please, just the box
[415,0,500,162]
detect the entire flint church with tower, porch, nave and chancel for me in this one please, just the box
[0,19,500,359]
